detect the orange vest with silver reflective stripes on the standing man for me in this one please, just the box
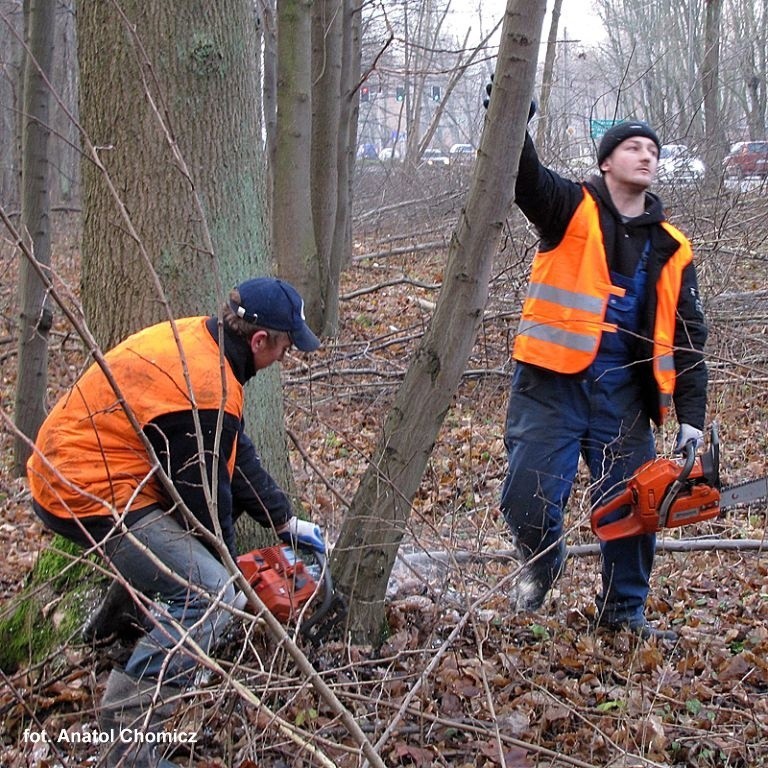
[513,190,693,420]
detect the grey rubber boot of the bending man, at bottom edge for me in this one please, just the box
[99,669,181,768]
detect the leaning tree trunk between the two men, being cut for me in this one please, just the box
[332,0,545,644]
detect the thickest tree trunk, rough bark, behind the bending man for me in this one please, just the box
[77,0,292,498]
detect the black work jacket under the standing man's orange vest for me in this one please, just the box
[515,133,707,429]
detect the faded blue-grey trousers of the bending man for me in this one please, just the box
[104,509,245,686]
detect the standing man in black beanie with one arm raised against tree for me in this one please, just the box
[501,114,707,640]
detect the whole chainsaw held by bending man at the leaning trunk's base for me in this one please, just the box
[237,544,347,645]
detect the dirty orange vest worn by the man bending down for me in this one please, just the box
[27,317,243,518]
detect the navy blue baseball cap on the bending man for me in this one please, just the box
[230,277,320,352]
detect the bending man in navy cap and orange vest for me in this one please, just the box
[28,278,324,768]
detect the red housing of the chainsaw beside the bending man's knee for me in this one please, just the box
[237,545,317,624]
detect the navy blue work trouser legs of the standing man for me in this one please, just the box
[501,354,656,623]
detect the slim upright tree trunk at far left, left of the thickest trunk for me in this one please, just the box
[14,0,55,477]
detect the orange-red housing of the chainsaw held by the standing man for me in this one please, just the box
[591,457,720,541]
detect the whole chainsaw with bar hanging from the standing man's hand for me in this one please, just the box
[591,424,768,541]
